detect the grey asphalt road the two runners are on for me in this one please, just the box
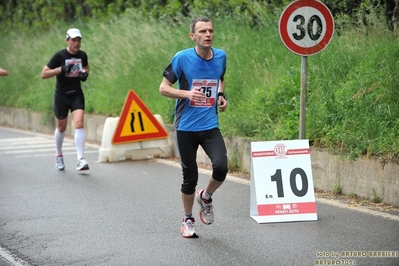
[0,127,399,266]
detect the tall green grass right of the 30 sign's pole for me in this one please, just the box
[308,8,399,158]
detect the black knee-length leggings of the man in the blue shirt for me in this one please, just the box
[176,128,228,195]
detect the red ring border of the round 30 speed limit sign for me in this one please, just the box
[279,0,334,56]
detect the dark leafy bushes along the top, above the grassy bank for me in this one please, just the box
[0,0,394,31]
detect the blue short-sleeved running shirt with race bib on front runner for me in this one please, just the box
[163,48,226,132]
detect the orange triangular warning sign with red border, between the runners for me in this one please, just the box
[112,90,168,144]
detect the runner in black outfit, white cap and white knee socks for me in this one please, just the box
[41,28,90,171]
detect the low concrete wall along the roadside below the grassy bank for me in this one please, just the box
[0,106,399,206]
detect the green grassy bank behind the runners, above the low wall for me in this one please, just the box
[0,14,399,159]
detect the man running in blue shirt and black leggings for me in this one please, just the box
[159,18,228,238]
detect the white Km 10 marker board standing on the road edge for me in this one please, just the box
[250,140,317,223]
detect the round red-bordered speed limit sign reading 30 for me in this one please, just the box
[279,0,334,56]
